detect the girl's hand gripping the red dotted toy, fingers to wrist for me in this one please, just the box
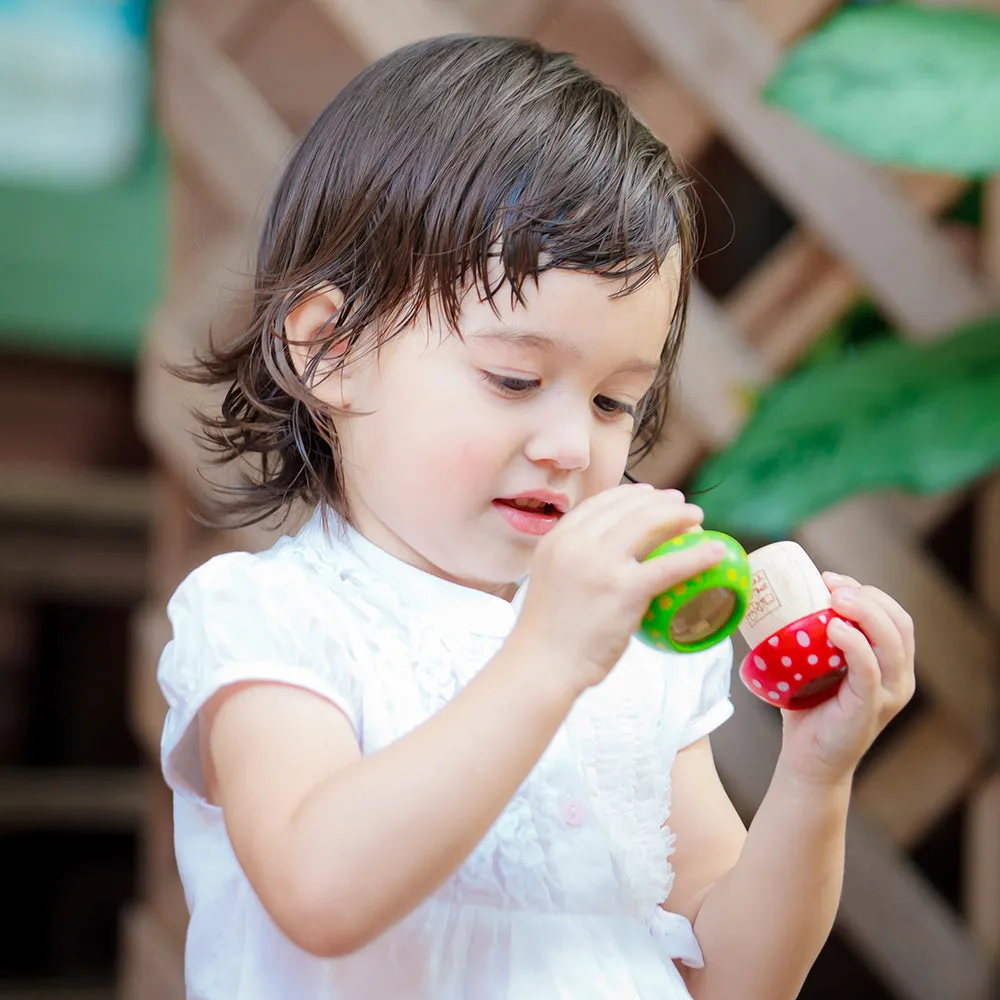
[781,573,916,782]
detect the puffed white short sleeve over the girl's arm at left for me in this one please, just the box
[157,552,361,799]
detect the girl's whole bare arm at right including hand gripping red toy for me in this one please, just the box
[670,574,914,1000]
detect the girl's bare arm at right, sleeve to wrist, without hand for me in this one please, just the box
[669,738,850,1000]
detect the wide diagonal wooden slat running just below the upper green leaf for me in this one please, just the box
[618,0,995,336]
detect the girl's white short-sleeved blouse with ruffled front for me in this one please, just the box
[159,514,732,1000]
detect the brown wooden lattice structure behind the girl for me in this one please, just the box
[131,0,1000,1000]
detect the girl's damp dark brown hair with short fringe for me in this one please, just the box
[185,36,693,524]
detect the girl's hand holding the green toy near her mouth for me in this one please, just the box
[512,483,725,691]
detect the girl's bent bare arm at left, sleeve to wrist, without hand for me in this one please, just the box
[202,628,578,955]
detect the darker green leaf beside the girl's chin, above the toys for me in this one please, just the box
[692,315,1000,538]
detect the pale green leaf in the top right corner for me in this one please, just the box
[763,3,1000,177]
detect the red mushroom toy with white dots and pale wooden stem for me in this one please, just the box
[740,542,847,709]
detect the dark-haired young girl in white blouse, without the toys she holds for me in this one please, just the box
[160,31,913,1000]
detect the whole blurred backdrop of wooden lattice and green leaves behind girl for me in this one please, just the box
[0,0,1000,1000]
